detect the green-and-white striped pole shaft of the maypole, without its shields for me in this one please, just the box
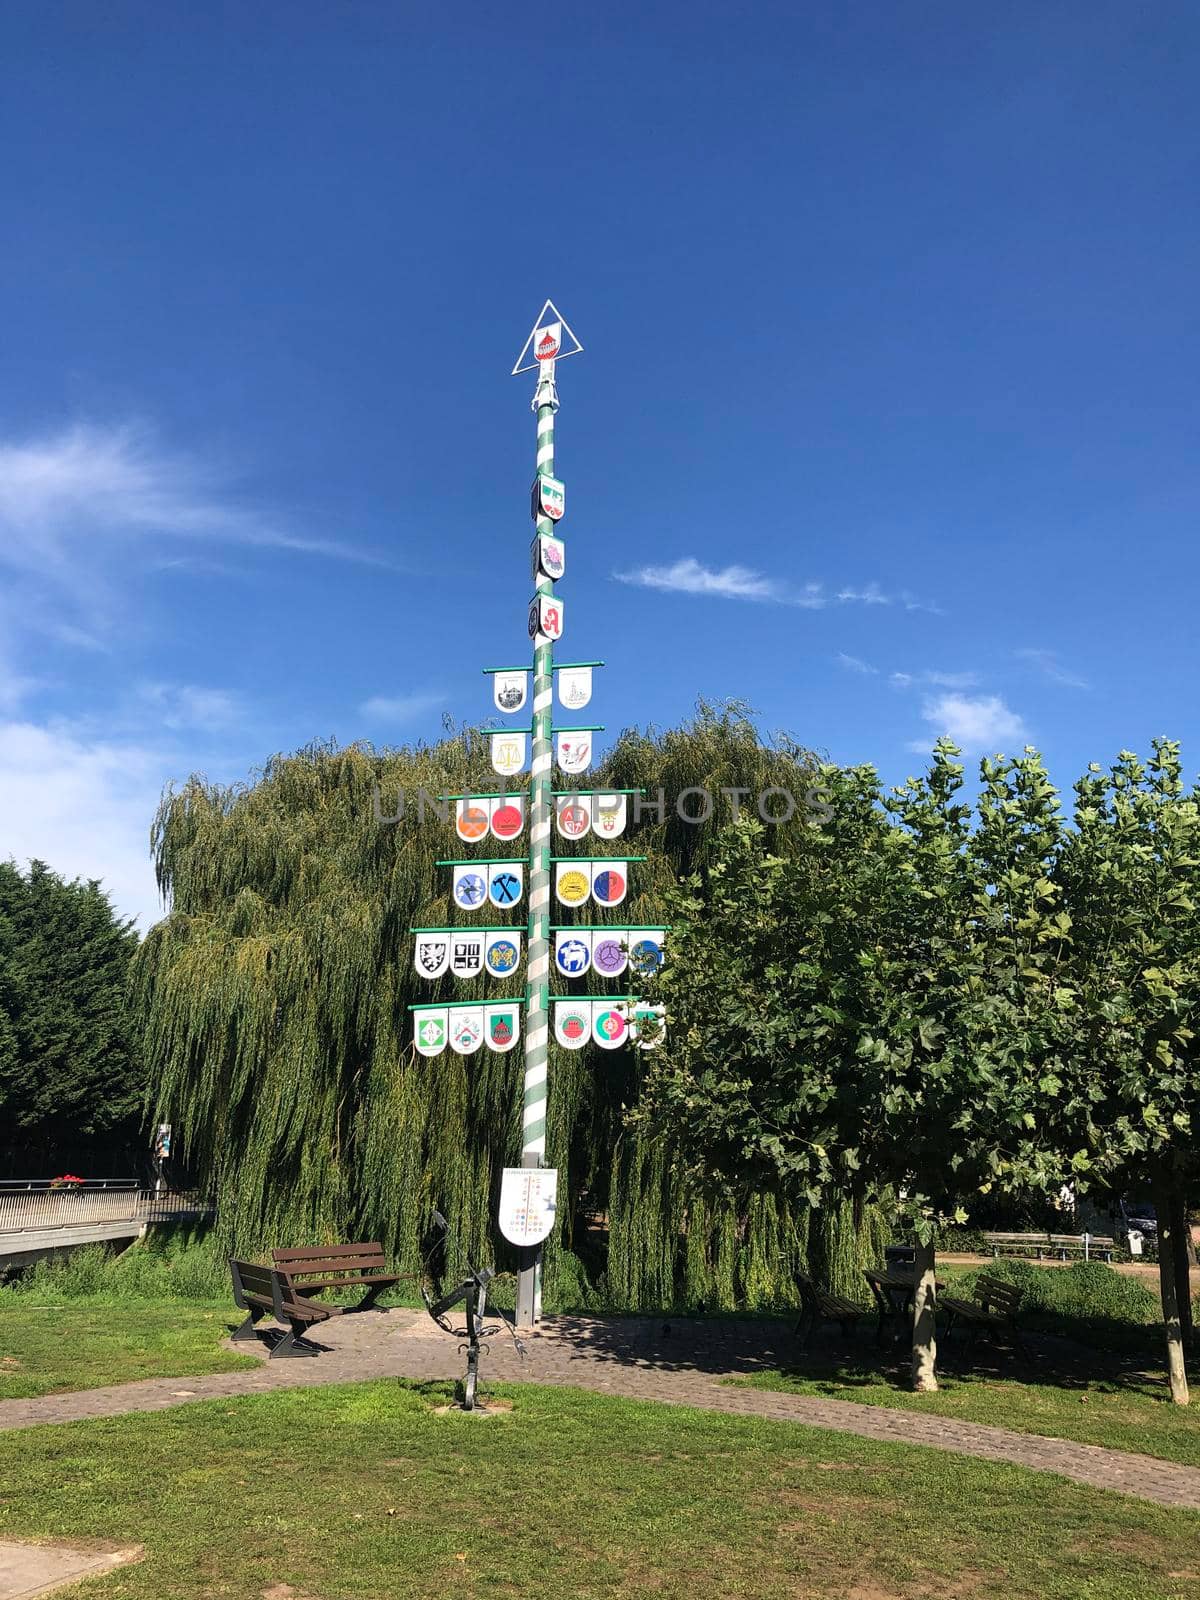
[517,360,558,1328]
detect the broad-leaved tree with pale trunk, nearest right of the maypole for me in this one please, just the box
[635,741,1090,1389]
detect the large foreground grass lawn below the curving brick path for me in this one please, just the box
[0,1381,1200,1600]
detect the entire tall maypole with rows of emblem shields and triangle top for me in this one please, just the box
[408,301,666,1328]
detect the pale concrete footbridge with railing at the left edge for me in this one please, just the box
[0,1178,213,1274]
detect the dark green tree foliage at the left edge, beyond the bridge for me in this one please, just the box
[0,861,144,1146]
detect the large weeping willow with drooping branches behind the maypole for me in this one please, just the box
[136,706,875,1307]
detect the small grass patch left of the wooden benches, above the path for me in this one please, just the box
[0,1299,258,1400]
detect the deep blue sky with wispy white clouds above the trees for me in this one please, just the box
[0,0,1200,925]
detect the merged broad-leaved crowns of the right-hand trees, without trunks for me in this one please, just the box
[634,741,1200,1235]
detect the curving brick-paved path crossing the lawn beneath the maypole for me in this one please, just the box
[0,1310,1200,1510]
